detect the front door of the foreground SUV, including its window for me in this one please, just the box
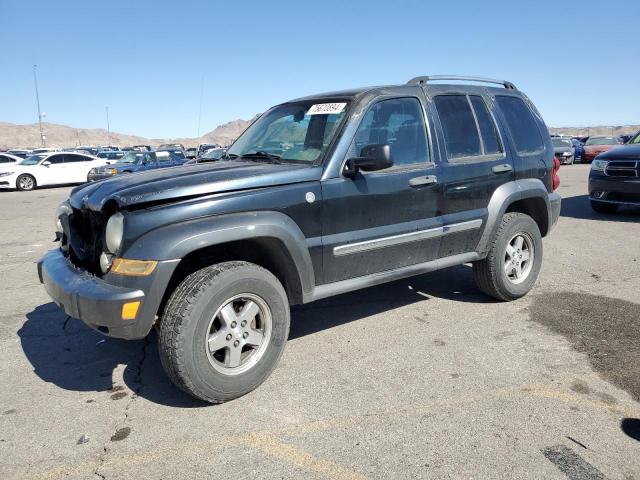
[322,97,441,283]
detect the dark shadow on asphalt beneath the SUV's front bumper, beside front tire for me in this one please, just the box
[18,302,208,408]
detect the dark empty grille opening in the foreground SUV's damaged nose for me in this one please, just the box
[65,208,106,275]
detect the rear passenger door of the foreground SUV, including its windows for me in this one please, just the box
[432,90,514,258]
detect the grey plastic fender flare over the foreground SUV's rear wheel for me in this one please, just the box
[476,178,553,254]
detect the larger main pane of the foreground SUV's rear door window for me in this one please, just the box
[434,95,482,160]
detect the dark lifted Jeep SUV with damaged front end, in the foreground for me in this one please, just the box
[38,77,560,403]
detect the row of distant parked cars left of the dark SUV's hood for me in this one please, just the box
[0,144,225,191]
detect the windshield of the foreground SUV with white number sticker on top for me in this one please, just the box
[228,100,347,163]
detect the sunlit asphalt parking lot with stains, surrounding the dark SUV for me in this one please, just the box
[0,165,640,479]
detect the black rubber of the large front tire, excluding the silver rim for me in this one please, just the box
[158,261,289,403]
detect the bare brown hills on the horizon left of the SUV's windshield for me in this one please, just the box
[0,120,253,149]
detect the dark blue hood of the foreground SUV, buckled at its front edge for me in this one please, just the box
[70,161,322,211]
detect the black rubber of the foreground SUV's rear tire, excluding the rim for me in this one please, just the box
[473,212,543,301]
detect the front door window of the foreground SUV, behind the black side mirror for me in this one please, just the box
[349,98,429,166]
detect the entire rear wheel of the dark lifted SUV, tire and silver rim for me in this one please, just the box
[473,212,542,300]
